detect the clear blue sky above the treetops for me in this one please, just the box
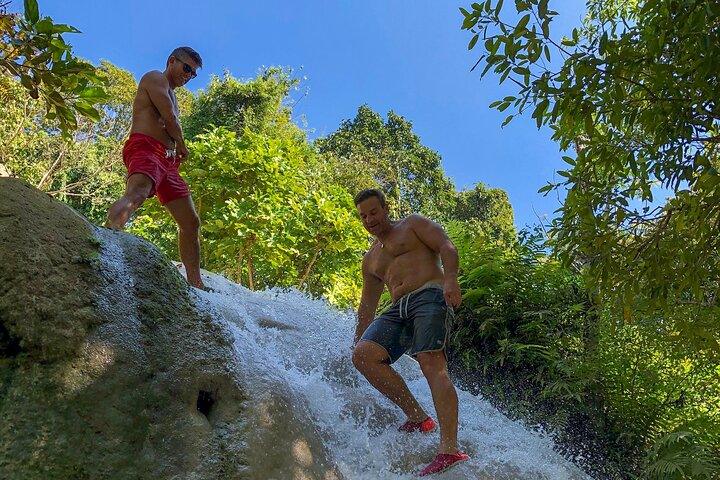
[11,0,585,227]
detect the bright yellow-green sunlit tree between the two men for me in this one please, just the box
[132,127,367,306]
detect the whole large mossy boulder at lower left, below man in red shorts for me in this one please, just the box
[0,178,248,480]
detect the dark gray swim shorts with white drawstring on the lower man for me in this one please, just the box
[361,283,453,363]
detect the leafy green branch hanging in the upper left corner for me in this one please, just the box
[0,0,107,133]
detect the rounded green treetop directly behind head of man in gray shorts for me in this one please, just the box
[315,105,454,220]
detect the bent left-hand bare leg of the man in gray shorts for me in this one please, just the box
[353,340,427,422]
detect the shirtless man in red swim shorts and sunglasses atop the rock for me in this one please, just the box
[106,47,204,288]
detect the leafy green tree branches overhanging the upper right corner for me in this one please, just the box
[462,0,720,318]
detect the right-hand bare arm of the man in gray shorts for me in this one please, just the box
[409,215,462,307]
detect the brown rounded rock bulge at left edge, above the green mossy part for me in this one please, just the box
[0,178,100,361]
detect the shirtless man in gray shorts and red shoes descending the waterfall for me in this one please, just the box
[353,190,469,476]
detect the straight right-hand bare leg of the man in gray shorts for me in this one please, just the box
[417,351,458,453]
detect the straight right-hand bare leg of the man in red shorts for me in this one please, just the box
[165,196,205,288]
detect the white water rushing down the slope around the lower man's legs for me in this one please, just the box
[188,268,589,480]
